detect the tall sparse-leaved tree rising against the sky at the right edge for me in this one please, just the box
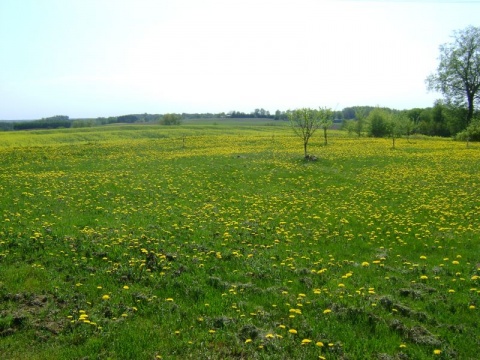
[426,26,480,126]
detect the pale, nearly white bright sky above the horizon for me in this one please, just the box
[0,0,480,120]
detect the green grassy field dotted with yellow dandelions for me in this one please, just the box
[0,121,480,359]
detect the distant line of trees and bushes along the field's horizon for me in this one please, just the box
[0,100,480,141]
